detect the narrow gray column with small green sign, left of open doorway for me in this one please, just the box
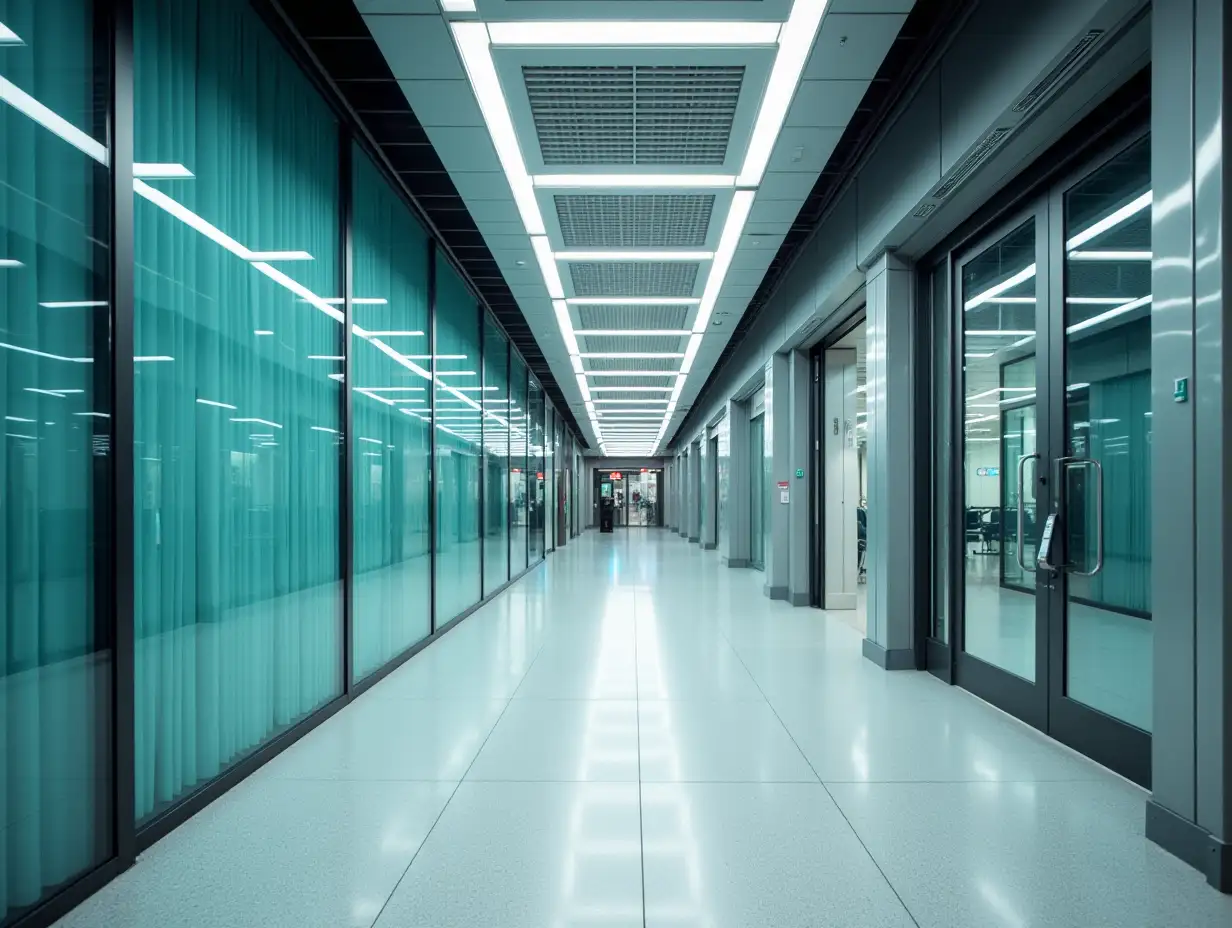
[780,351,813,606]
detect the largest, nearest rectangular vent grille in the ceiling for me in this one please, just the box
[522,65,744,165]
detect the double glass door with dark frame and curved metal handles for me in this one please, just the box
[952,130,1152,784]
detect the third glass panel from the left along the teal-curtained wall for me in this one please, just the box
[352,147,432,680]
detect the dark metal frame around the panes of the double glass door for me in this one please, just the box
[929,126,1151,788]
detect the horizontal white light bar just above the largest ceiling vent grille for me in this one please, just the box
[488,20,778,46]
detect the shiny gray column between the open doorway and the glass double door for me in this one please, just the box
[864,253,915,670]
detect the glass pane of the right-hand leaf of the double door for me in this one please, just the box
[1063,139,1154,731]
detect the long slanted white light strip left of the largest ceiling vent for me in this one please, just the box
[450,22,549,235]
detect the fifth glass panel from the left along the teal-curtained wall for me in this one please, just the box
[483,314,510,593]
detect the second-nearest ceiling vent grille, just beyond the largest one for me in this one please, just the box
[554,193,715,248]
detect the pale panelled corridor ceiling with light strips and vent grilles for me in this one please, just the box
[340,0,914,455]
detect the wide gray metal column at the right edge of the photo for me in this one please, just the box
[1147,0,1232,892]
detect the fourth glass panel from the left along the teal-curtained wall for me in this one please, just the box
[432,251,483,627]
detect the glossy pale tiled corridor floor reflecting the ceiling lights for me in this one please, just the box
[52,530,1232,928]
